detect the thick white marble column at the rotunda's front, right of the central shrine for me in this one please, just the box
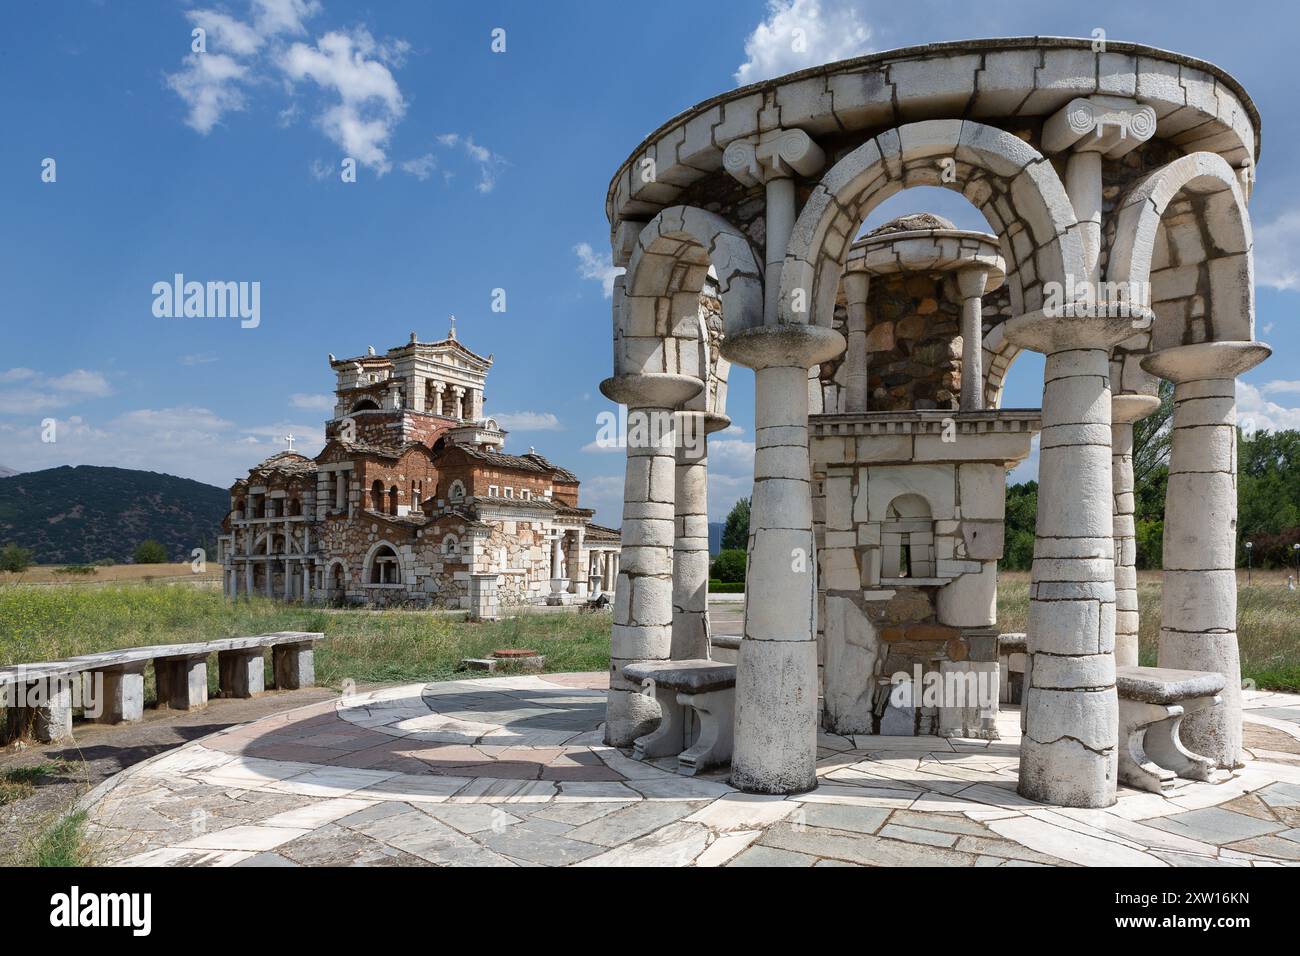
[1006,312,1132,808]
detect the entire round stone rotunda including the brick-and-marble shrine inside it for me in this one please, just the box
[602,38,1269,806]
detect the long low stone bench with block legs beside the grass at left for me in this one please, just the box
[0,631,325,744]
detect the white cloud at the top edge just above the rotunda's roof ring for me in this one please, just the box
[736,0,871,86]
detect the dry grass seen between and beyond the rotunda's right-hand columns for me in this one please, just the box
[997,571,1300,692]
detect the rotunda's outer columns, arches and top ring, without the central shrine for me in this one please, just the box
[606,39,1268,808]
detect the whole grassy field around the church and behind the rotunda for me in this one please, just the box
[0,564,1300,691]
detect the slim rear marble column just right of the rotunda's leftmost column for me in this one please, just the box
[672,411,731,661]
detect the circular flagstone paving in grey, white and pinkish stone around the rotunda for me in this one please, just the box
[83,674,1300,866]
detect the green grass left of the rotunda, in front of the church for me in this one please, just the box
[0,584,610,687]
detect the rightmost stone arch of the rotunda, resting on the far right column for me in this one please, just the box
[1106,152,1255,347]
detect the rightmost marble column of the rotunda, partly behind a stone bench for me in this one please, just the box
[1141,342,1271,767]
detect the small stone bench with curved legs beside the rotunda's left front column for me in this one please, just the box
[623,661,736,777]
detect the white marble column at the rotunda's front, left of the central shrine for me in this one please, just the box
[723,324,845,793]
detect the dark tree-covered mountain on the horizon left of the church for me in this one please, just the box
[0,464,230,564]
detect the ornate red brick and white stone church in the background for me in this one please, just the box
[218,328,619,609]
